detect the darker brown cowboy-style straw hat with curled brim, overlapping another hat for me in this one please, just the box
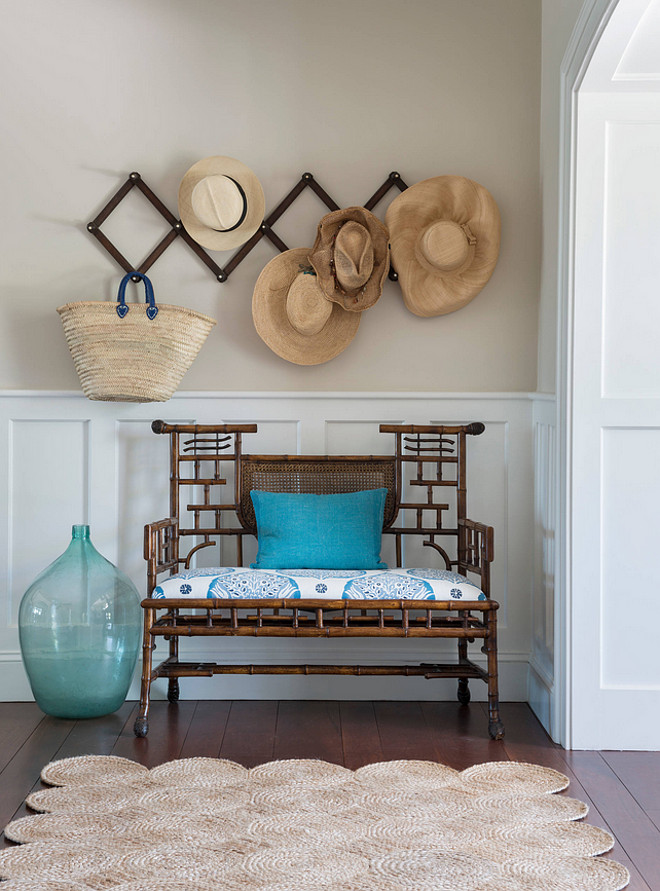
[309,207,390,312]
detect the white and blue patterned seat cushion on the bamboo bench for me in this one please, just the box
[151,566,486,600]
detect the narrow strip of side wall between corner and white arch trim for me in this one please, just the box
[538,0,592,393]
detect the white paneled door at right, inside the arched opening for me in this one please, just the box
[568,92,660,749]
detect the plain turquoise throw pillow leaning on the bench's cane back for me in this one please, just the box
[250,489,387,569]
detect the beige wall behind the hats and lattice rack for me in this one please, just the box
[0,0,540,391]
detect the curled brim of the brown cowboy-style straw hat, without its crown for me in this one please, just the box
[309,207,390,313]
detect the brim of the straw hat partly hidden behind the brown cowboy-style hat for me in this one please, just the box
[252,248,360,365]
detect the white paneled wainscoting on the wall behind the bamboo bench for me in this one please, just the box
[0,392,536,713]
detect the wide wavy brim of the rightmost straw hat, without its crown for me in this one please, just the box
[385,176,500,317]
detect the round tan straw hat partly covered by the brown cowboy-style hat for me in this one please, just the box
[252,248,360,365]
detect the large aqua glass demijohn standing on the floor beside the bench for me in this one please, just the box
[18,526,141,718]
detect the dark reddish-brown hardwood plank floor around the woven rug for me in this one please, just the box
[0,700,660,891]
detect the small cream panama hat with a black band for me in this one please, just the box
[179,155,266,251]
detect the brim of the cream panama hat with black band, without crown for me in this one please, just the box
[179,155,266,251]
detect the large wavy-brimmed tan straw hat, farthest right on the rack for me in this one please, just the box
[385,176,500,316]
